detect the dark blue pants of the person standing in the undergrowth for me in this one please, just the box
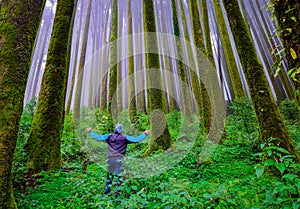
[104,158,124,194]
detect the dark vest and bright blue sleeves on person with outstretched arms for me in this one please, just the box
[89,132,147,158]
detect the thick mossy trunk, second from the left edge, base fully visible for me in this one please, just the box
[26,0,74,173]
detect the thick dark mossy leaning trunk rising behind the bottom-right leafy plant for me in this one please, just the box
[224,0,299,161]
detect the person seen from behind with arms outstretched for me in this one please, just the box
[86,124,150,194]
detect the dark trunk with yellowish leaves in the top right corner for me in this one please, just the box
[271,0,300,106]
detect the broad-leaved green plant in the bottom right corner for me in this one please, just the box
[256,138,300,208]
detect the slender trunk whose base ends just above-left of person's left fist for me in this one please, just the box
[73,0,92,127]
